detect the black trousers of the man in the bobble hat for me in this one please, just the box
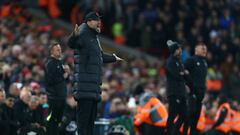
[166,96,187,135]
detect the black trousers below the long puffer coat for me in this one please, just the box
[77,99,98,135]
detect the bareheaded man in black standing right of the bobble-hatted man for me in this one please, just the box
[184,43,208,135]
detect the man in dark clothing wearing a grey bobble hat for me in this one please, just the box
[166,40,188,135]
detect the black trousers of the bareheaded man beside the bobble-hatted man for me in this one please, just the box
[188,93,204,135]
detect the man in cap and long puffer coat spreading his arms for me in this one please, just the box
[68,12,122,135]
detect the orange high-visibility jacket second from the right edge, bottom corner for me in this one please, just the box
[215,103,233,133]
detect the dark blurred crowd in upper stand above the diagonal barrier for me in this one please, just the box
[54,0,240,98]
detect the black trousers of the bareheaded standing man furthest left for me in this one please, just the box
[47,99,66,135]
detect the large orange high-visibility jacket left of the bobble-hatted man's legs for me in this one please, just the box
[134,97,168,127]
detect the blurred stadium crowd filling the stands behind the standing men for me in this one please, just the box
[0,0,240,135]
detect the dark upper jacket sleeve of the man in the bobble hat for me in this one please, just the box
[166,60,182,81]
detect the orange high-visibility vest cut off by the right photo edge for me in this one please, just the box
[231,110,240,133]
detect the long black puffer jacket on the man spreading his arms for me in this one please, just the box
[68,23,116,100]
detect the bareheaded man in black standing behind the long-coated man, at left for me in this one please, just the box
[44,43,70,135]
